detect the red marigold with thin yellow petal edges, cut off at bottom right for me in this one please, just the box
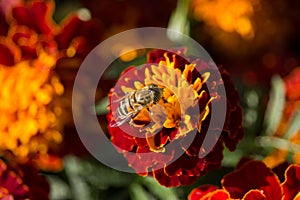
[188,160,300,200]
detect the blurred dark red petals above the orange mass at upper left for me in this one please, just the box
[1,1,102,62]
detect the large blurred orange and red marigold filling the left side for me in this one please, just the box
[0,1,101,171]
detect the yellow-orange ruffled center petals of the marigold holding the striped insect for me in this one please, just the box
[121,54,213,151]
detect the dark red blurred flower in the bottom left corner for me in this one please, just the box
[0,159,49,200]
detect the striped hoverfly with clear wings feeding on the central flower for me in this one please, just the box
[111,84,163,127]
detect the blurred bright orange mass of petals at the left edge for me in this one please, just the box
[0,53,64,158]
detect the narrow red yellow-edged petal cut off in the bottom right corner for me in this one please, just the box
[282,165,300,200]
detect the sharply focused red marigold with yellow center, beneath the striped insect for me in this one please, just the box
[108,49,243,187]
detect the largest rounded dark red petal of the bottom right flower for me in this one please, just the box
[222,161,281,200]
